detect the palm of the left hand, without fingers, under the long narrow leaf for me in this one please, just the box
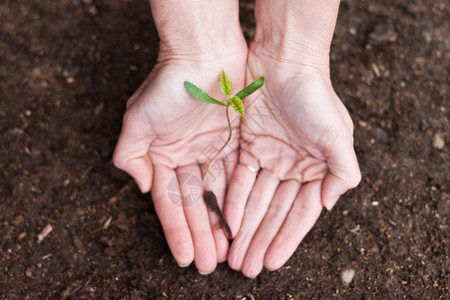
[129,65,243,169]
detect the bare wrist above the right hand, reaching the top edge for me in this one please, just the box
[251,0,340,69]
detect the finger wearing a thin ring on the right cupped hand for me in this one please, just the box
[224,153,259,236]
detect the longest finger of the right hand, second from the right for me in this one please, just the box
[241,180,300,278]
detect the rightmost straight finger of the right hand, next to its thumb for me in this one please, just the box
[264,181,322,270]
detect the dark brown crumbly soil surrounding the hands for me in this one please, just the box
[0,0,450,299]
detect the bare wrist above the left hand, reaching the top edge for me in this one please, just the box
[150,0,246,61]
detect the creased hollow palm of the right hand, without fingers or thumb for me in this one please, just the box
[241,76,327,182]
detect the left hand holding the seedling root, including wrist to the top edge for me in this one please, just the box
[113,0,247,274]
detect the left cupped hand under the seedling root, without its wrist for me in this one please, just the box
[114,46,247,273]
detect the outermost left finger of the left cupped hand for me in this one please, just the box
[152,165,194,266]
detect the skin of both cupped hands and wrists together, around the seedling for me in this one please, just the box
[114,0,360,277]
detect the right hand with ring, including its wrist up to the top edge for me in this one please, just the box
[224,0,361,277]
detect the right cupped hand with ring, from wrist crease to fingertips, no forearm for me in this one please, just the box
[225,50,360,277]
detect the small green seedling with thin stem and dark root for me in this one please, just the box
[184,70,264,239]
